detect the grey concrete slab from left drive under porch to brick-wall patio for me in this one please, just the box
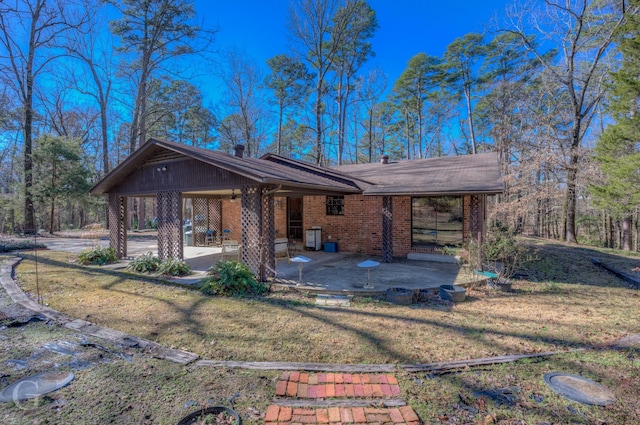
[35,237,474,295]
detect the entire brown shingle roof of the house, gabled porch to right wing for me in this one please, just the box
[90,139,503,195]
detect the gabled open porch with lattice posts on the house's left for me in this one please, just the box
[91,139,368,281]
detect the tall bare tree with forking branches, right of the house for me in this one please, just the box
[504,0,638,243]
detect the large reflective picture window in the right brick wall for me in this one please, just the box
[411,196,464,245]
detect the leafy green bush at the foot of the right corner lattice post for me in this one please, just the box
[199,260,268,296]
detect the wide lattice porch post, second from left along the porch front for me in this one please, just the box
[156,190,184,260]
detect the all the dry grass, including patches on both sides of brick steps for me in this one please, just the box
[0,241,640,424]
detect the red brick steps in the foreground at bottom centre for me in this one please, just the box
[265,372,420,425]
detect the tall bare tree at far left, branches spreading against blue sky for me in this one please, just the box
[0,0,86,232]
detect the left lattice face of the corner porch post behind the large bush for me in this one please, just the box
[240,186,262,278]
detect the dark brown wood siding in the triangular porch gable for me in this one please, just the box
[111,159,255,196]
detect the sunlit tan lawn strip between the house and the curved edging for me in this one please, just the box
[10,245,640,363]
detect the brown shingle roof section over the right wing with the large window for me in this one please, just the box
[335,153,503,195]
